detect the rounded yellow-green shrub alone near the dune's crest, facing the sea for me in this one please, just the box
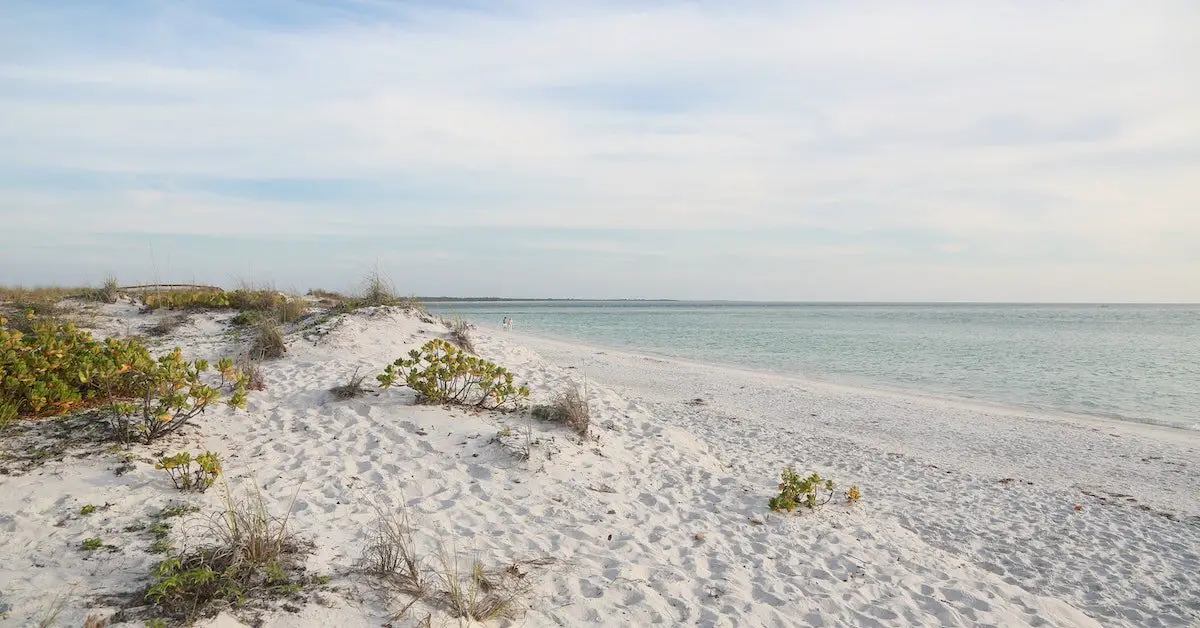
[377,339,529,409]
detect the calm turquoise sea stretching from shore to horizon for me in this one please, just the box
[431,301,1200,429]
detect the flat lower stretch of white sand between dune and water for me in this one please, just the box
[472,321,1200,626]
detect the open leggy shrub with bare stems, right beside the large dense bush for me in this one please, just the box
[108,348,247,443]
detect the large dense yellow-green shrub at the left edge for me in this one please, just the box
[0,317,152,415]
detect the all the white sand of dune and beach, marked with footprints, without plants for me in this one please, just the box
[0,303,1200,628]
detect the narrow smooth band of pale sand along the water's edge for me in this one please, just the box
[472,323,1200,444]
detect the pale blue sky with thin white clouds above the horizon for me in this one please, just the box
[0,0,1200,303]
